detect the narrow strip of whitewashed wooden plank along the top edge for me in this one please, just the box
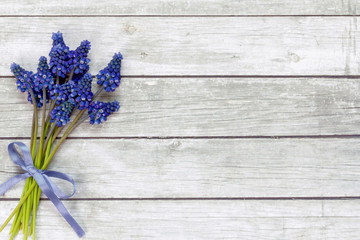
[0,0,360,16]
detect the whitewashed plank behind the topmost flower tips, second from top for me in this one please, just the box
[0,17,360,75]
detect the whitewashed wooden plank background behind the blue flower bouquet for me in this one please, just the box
[0,0,360,240]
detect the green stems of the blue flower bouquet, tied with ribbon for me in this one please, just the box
[0,74,104,240]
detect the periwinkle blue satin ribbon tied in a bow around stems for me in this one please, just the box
[0,142,85,237]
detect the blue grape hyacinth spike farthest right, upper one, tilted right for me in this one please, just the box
[96,53,123,92]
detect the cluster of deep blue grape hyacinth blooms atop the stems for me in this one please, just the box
[10,32,123,127]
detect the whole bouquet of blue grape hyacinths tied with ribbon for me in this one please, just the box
[0,32,123,239]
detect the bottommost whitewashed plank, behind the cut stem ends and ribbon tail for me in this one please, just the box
[0,201,360,240]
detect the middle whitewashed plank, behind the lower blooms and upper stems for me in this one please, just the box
[0,78,360,137]
